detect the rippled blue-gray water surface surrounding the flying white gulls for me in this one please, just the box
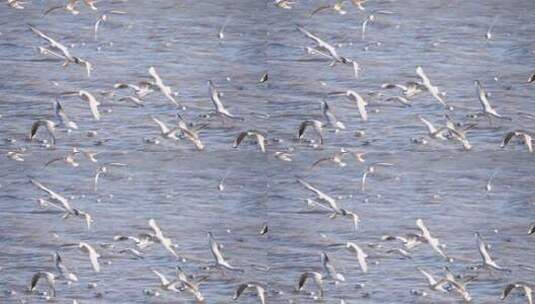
[0,0,535,303]
